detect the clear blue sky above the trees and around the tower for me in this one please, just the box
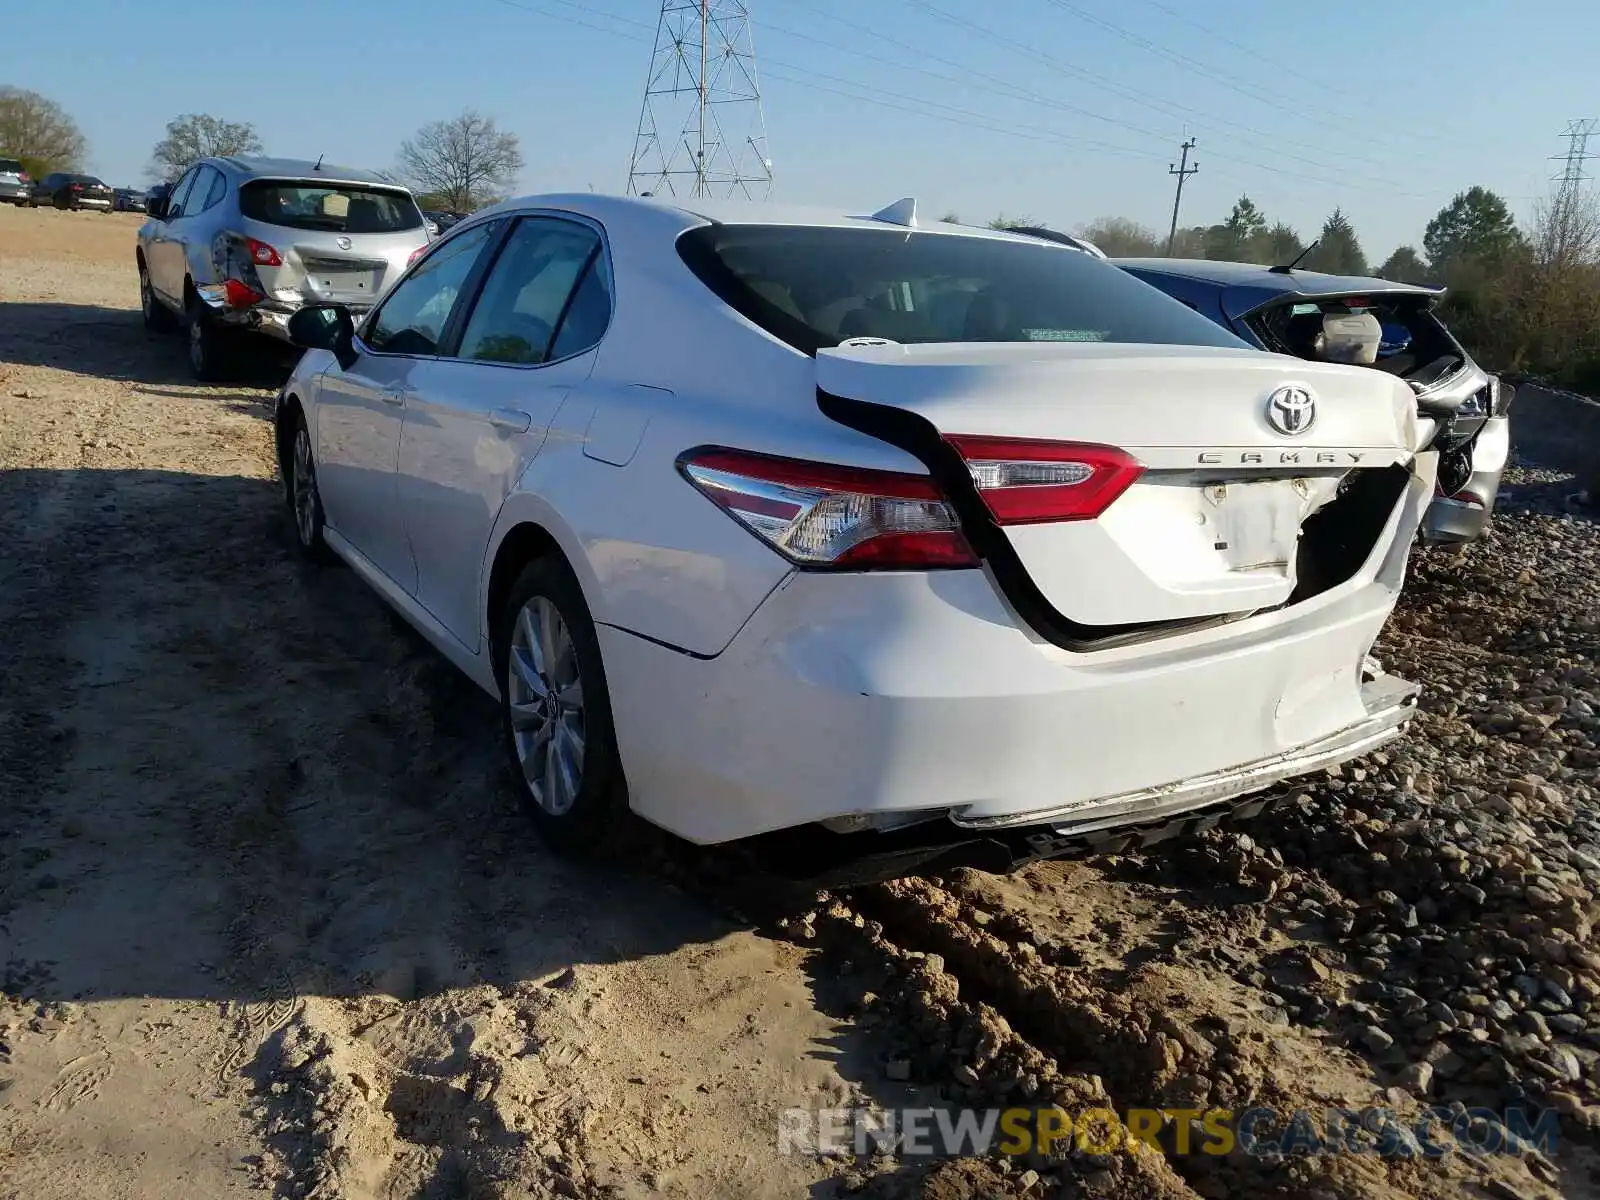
[0,0,1600,262]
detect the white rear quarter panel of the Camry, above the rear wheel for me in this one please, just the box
[480,217,922,656]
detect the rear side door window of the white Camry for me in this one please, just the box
[459,218,611,365]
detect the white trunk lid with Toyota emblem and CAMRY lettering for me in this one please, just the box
[816,341,1418,630]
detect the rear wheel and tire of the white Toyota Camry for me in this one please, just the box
[494,555,638,858]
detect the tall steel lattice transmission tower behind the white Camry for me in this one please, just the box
[627,0,773,200]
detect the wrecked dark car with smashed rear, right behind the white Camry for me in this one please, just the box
[1112,258,1515,542]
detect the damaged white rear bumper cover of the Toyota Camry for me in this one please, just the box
[597,451,1434,853]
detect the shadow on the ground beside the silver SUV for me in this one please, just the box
[0,301,299,387]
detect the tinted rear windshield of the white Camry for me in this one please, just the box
[678,226,1243,354]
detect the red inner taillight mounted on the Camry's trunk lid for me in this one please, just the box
[946,435,1144,525]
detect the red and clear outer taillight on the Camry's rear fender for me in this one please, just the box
[678,448,978,571]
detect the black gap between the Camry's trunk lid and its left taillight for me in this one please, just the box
[816,387,1216,650]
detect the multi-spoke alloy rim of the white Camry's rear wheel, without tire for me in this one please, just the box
[506,595,584,816]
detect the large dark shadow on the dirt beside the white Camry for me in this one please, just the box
[0,454,934,1196]
